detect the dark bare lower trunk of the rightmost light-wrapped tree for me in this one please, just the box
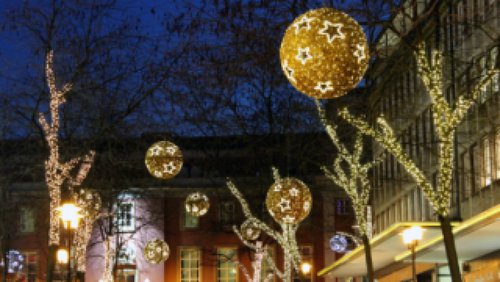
[438,215,462,282]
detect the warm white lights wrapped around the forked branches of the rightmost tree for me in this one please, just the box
[339,44,498,217]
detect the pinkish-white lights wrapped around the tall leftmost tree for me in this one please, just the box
[38,50,95,245]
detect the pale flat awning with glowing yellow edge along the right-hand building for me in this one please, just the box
[318,205,500,277]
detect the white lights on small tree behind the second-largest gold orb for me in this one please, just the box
[226,174,302,281]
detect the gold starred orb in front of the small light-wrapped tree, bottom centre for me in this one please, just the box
[266,177,312,224]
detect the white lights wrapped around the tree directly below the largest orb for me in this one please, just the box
[316,100,378,236]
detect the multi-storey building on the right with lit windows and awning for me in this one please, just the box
[323,0,500,281]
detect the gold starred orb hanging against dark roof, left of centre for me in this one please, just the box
[145,141,182,179]
